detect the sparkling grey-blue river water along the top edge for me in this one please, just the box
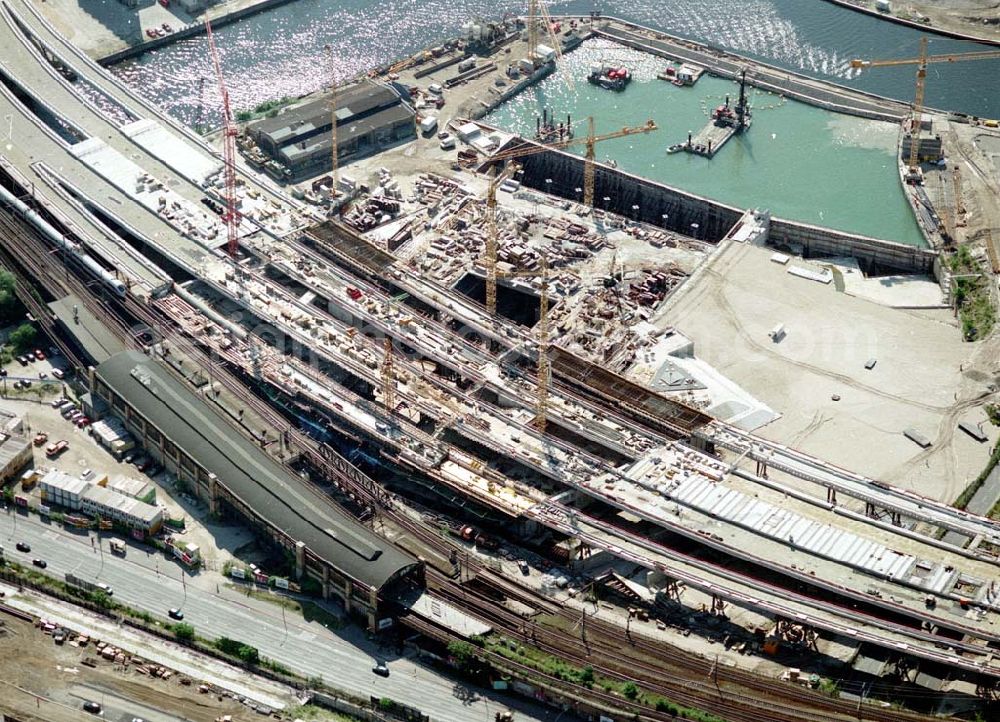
[113,0,1000,125]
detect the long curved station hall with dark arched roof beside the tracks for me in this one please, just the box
[88,351,423,629]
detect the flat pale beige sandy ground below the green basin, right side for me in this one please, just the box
[660,245,1000,501]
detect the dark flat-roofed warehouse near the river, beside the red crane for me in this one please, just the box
[247,80,416,181]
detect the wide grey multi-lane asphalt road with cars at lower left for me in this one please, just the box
[0,511,570,722]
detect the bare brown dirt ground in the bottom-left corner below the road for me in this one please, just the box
[0,604,261,722]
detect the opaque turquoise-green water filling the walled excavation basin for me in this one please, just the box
[486,40,925,246]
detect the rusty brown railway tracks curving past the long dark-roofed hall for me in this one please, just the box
[0,201,960,722]
